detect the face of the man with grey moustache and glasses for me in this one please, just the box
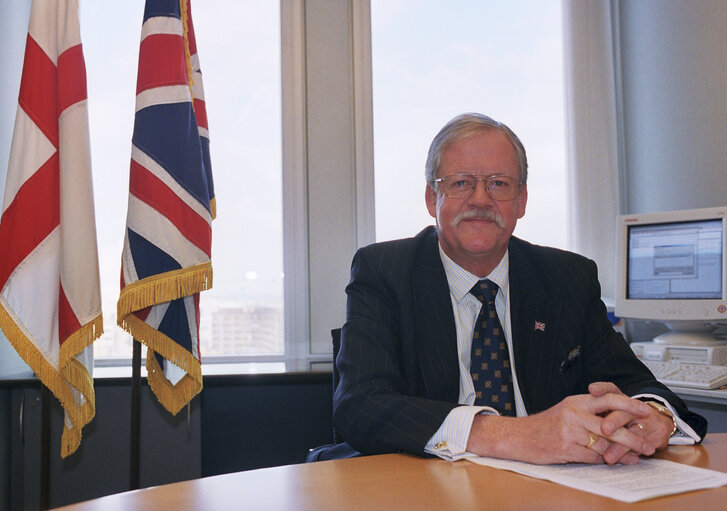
[426,128,528,277]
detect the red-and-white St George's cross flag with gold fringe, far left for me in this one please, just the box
[0,0,103,457]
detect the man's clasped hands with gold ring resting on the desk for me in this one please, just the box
[467,382,673,465]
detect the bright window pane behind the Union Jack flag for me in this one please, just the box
[80,0,284,362]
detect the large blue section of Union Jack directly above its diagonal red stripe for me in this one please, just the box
[133,102,211,215]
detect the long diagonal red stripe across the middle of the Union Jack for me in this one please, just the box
[129,160,212,256]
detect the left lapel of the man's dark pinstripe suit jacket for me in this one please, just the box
[412,232,459,402]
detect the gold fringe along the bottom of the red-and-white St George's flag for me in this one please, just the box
[0,303,103,458]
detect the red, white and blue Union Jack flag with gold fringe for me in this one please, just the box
[117,0,214,414]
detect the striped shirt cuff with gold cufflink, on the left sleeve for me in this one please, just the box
[424,405,498,461]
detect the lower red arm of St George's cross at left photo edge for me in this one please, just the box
[0,152,61,289]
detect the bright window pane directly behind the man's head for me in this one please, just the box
[371,0,566,248]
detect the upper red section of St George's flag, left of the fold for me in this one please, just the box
[18,34,58,148]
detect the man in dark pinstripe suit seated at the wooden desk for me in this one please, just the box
[334,114,706,464]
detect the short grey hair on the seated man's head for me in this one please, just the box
[424,113,528,190]
